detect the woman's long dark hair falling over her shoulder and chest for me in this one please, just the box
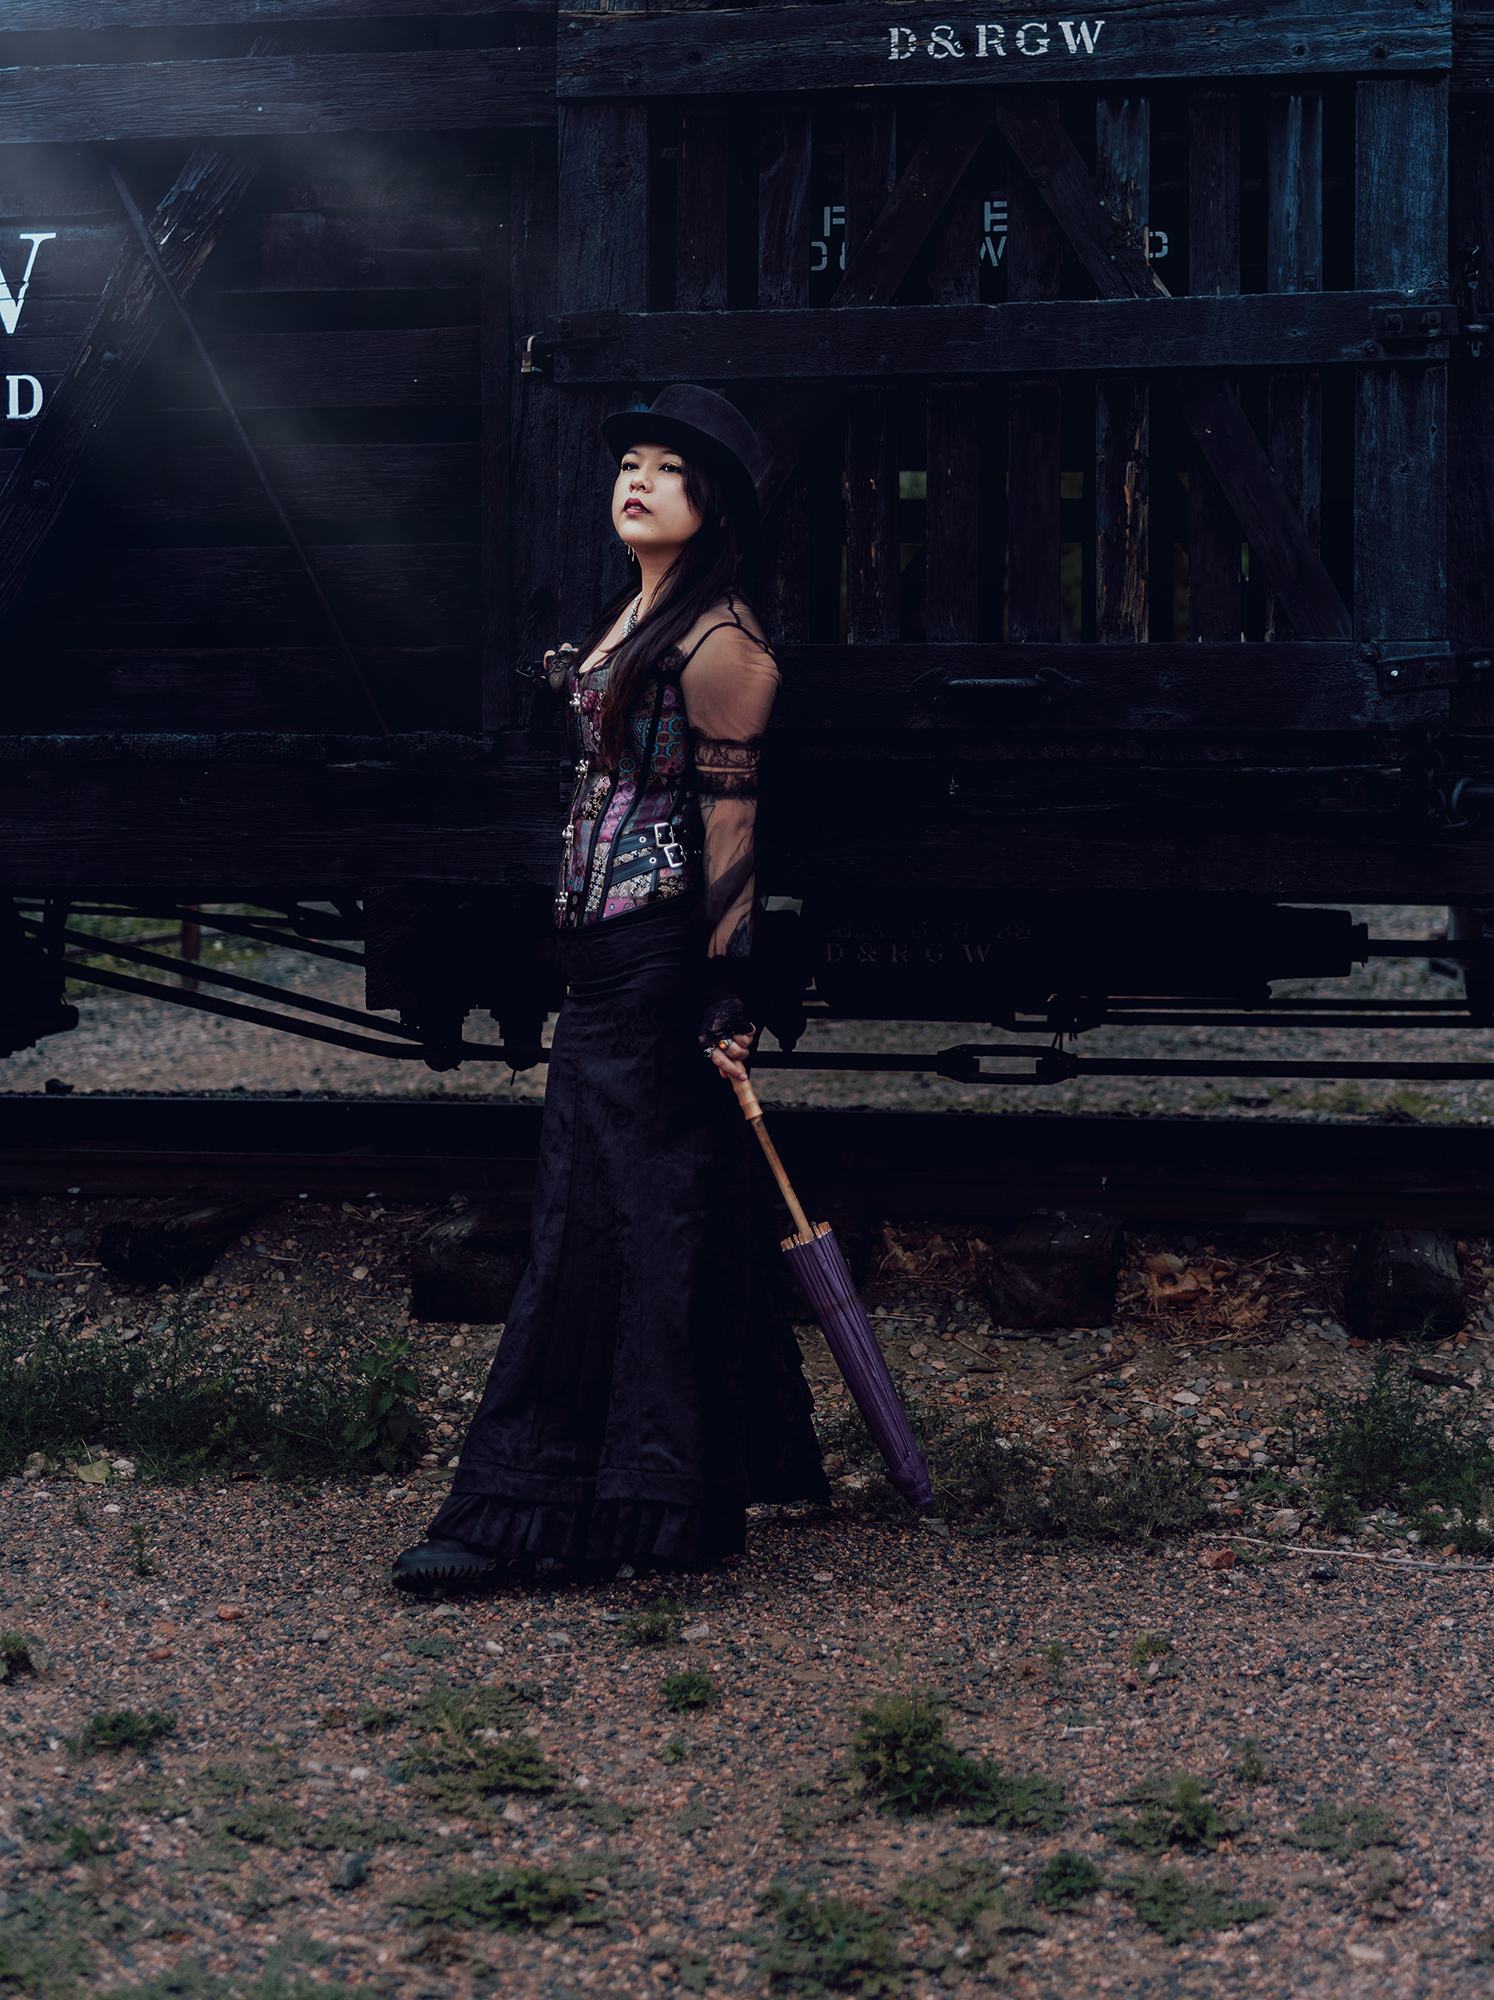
[582,458,764,770]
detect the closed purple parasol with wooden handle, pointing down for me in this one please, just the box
[732,1084,934,1506]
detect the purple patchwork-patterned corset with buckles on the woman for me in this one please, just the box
[556,652,702,928]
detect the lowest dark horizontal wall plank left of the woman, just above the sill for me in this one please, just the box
[4,646,482,736]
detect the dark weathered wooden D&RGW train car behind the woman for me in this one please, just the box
[0,0,1494,1088]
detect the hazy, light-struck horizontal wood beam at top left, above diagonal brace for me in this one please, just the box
[0,48,556,146]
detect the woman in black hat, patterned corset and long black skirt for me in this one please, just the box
[394,384,828,1578]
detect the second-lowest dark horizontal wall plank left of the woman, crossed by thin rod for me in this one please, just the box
[42,542,480,644]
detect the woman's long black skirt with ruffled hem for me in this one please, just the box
[430,902,828,1566]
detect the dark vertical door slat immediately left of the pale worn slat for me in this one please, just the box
[1002,104,1064,644]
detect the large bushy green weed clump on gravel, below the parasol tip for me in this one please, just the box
[850,1694,1064,1832]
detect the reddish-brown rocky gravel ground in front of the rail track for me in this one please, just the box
[0,1200,1494,2000]
